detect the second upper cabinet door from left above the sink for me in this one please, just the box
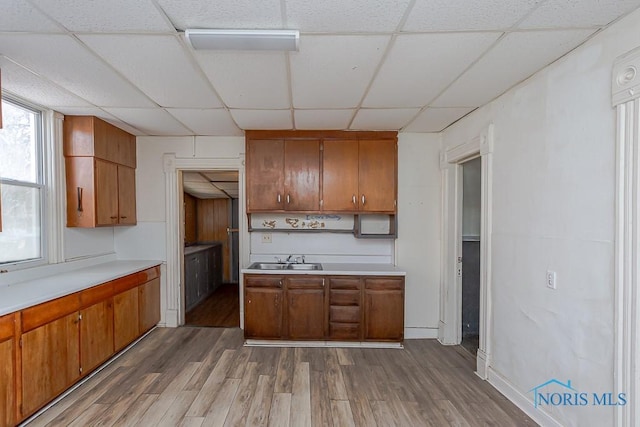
[284,139,320,211]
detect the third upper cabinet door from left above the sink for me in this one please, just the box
[322,139,359,212]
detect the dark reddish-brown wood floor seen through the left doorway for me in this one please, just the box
[185,283,240,328]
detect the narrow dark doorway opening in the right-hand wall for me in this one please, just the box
[460,157,482,357]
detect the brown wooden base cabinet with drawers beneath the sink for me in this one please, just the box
[244,274,404,342]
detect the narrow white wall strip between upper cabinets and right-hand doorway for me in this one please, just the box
[396,133,442,338]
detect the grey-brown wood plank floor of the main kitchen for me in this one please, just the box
[30,327,536,427]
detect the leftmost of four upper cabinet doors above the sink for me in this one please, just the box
[247,139,285,212]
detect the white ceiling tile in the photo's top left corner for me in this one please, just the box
[0,0,64,33]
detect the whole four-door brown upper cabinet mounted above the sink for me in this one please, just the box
[246,131,397,214]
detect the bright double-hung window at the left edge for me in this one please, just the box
[0,99,45,264]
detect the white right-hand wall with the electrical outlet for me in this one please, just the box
[443,11,640,426]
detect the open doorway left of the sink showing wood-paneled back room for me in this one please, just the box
[181,170,240,327]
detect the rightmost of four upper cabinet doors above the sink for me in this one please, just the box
[358,139,397,213]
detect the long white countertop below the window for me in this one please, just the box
[0,260,160,316]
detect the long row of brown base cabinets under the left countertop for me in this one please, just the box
[0,267,160,427]
